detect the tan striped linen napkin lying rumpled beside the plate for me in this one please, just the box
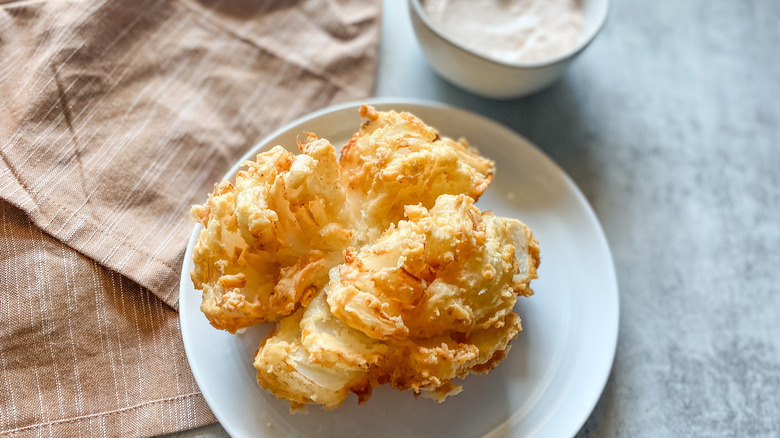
[0,0,380,436]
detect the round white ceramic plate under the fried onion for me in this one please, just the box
[180,100,618,438]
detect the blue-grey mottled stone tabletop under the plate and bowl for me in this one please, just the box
[172,0,780,437]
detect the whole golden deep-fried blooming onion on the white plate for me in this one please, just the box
[191,106,539,410]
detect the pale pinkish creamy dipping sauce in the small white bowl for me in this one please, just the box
[421,0,582,63]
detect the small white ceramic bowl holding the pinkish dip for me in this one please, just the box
[409,0,609,99]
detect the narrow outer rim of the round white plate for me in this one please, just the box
[177,97,620,436]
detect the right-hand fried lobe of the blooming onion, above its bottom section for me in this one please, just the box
[328,195,538,339]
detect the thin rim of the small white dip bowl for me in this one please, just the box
[408,0,610,69]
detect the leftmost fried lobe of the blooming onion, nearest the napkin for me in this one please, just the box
[191,134,354,333]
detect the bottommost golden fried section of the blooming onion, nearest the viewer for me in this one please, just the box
[255,293,521,409]
